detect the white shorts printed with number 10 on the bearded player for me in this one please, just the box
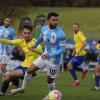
[33,56,60,78]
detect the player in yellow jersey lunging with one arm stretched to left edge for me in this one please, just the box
[0,25,42,95]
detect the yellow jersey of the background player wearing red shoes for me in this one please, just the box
[74,31,86,56]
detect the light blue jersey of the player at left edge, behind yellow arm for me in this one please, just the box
[0,26,16,54]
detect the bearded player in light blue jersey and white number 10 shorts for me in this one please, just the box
[11,12,65,100]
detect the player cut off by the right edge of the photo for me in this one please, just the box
[93,40,100,91]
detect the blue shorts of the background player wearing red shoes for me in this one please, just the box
[68,56,86,66]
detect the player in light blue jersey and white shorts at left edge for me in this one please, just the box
[0,18,16,76]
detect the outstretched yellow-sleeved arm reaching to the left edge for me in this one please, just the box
[0,38,21,45]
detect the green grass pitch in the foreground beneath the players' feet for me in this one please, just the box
[0,72,100,100]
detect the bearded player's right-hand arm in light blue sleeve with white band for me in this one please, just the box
[48,37,66,57]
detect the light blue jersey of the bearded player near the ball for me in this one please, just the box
[34,25,65,64]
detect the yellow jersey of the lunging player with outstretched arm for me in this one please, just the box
[0,38,43,67]
